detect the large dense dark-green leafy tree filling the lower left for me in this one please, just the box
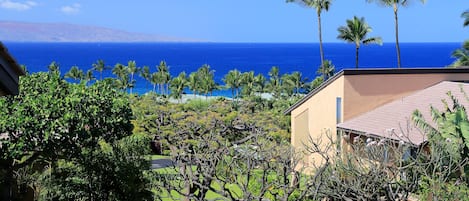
[0,72,151,200]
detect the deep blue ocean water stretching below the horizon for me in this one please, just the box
[5,42,461,93]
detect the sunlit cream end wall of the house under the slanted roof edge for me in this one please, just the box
[291,76,344,169]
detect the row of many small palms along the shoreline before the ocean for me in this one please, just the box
[57,60,314,100]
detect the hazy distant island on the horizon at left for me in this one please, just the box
[0,21,197,42]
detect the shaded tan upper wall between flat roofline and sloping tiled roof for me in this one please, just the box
[343,72,469,121]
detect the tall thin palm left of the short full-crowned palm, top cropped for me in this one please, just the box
[287,0,332,66]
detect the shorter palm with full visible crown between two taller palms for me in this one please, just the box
[337,16,383,68]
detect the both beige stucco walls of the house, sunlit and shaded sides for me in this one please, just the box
[291,72,469,169]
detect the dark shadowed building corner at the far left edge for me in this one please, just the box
[0,42,25,96]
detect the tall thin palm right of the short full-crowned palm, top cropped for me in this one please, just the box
[367,0,426,68]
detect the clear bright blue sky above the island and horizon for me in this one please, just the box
[0,0,469,42]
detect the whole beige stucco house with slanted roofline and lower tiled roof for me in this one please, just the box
[284,68,469,169]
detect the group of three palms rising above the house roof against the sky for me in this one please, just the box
[286,0,426,69]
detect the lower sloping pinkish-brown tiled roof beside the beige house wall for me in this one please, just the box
[337,81,469,145]
